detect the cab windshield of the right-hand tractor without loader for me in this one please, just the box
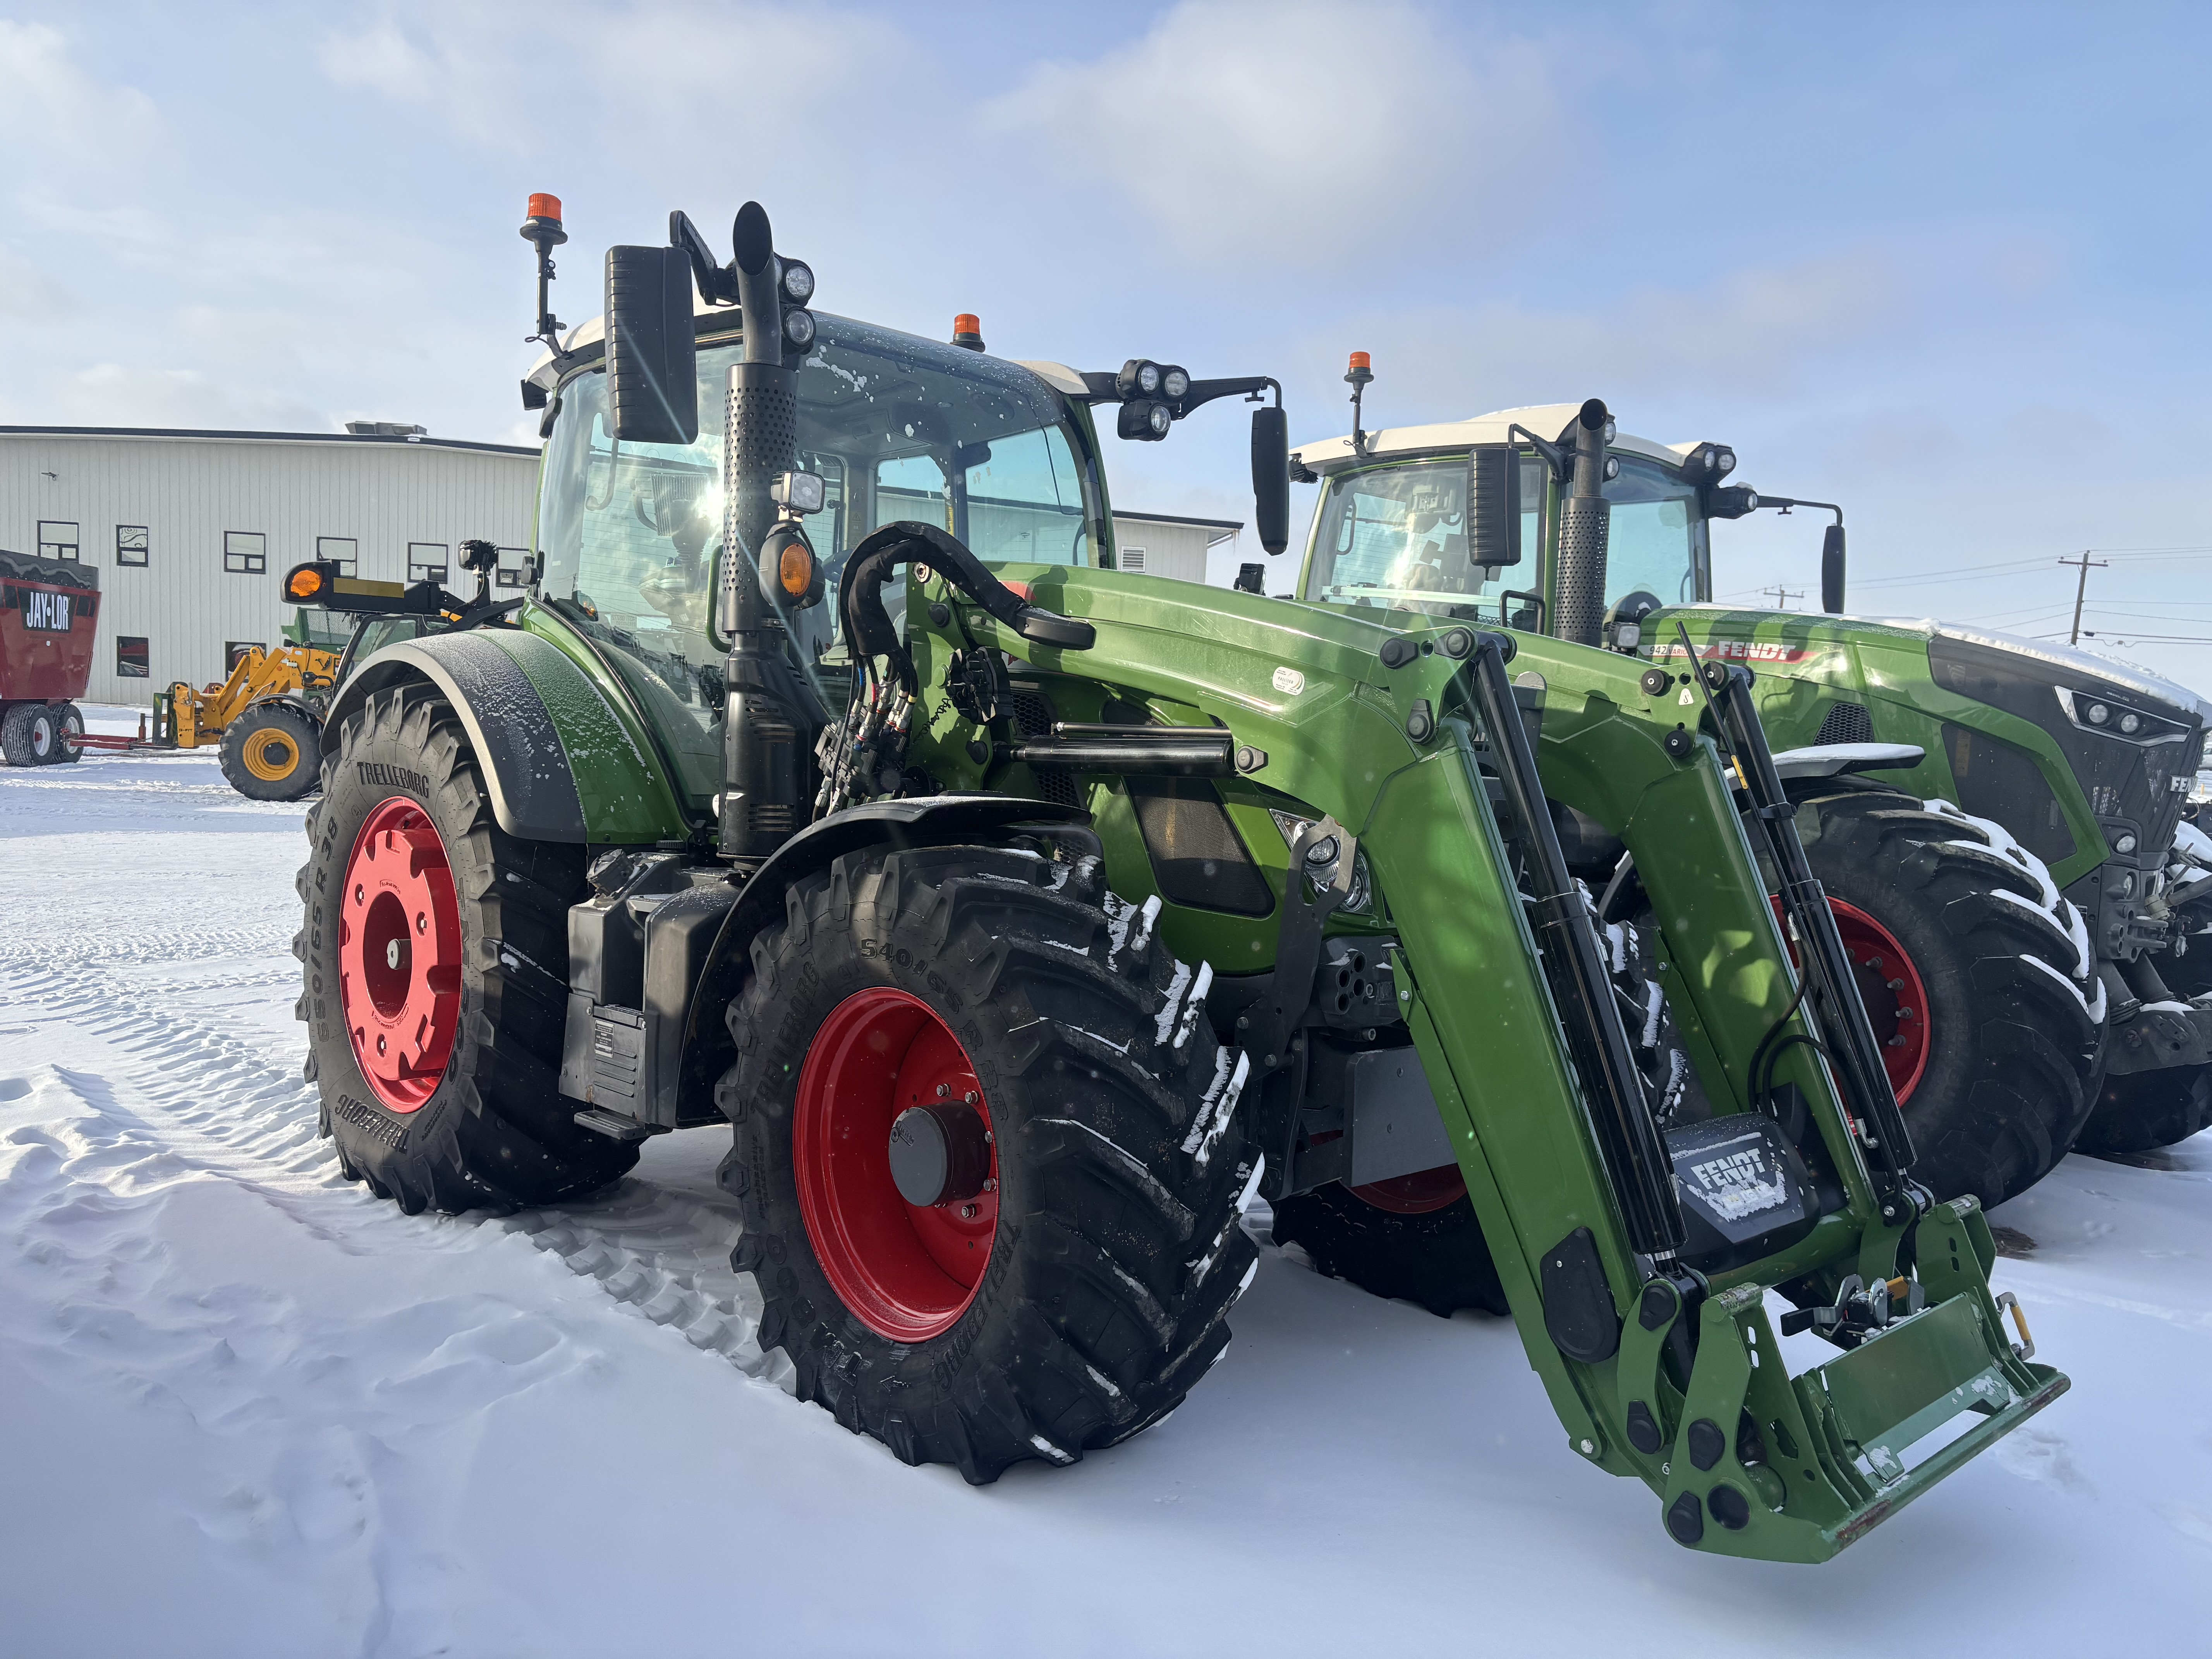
[1305,453,1544,615]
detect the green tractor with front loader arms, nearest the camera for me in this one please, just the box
[288,197,2066,1562]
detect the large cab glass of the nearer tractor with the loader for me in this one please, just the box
[538,314,1097,801]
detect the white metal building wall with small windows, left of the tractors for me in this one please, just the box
[0,422,538,703]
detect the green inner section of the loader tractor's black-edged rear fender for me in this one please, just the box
[507,604,690,845]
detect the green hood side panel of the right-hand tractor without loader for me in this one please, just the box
[1644,606,2106,887]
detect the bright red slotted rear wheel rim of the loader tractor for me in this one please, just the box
[338,796,460,1113]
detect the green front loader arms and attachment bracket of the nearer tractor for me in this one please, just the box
[889,566,2064,1562]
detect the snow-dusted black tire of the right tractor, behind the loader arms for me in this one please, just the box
[1798,790,2104,1208]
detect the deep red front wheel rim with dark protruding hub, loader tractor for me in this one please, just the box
[792,987,998,1343]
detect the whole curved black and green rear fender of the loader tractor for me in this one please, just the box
[325,628,690,845]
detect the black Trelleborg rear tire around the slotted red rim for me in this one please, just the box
[292,686,637,1214]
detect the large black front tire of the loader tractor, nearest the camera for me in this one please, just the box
[717,847,1256,1484]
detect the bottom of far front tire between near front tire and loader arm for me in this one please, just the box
[1274,1181,1511,1318]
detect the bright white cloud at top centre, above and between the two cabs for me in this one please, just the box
[982,0,1571,264]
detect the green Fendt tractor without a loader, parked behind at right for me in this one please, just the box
[1294,376,2212,1206]
